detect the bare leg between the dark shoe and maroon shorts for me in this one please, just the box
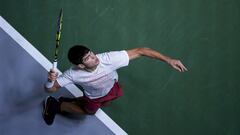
[61,102,86,114]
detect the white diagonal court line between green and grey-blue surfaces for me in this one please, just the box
[0,16,127,135]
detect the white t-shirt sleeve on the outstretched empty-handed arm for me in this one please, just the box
[99,50,129,70]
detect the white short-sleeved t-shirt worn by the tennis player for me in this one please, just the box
[57,50,129,99]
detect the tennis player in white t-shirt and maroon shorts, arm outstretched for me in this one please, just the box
[43,45,187,125]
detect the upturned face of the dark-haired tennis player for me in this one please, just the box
[79,51,99,69]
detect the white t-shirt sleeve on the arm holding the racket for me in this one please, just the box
[57,70,73,87]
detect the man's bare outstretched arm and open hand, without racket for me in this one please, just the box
[127,47,187,72]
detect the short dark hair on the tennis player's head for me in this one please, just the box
[68,45,90,65]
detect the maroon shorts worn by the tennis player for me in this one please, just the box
[80,82,123,114]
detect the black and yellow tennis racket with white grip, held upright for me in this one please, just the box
[53,8,63,70]
